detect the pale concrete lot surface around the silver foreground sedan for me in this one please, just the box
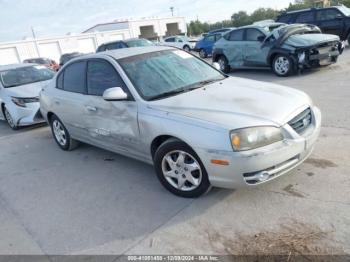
[0,49,350,255]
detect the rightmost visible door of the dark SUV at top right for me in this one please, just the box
[316,8,344,36]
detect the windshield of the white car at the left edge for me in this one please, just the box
[0,66,55,88]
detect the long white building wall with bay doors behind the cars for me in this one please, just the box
[0,17,187,65]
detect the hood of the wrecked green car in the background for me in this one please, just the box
[284,34,339,47]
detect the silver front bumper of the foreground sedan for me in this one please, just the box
[196,107,321,188]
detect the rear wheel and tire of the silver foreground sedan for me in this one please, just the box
[50,115,79,151]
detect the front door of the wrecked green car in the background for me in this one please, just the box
[243,28,270,67]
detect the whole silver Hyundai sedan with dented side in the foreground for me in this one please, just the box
[40,47,321,197]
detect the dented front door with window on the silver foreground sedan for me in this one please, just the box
[84,59,139,155]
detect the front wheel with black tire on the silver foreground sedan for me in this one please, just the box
[154,139,211,198]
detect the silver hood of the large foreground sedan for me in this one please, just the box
[149,77,311,128]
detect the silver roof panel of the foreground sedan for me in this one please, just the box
[77,46,177,61]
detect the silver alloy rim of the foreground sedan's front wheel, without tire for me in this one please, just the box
[162,150,202,191]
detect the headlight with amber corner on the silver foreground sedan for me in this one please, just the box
[230,126,283,151]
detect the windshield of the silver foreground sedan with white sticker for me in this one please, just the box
[118,50,225,100]
